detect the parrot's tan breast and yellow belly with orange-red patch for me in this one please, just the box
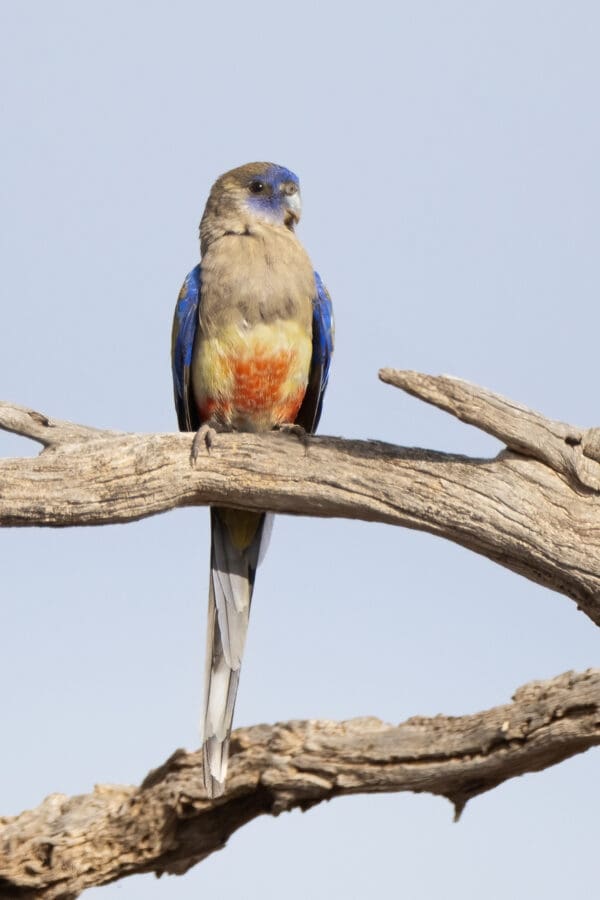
[192,228,316,431]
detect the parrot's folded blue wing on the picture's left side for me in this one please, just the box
[171,265,202,431]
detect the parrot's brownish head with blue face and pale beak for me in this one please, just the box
[200,162,302,250]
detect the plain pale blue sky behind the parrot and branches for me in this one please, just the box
[0,0,600,900]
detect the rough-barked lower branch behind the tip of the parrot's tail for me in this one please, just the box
[0,669,600,900]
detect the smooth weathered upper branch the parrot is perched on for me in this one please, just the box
[0,369,600,624]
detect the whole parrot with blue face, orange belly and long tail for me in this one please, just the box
[172,162,333,797]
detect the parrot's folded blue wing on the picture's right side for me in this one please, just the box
[296,272,334,434]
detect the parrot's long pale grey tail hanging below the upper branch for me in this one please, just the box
[203,508,271,797]
